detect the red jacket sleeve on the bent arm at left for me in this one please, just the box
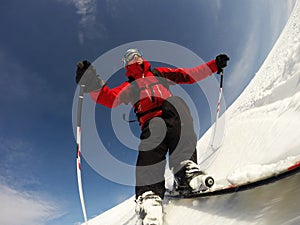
[90,82,130,108]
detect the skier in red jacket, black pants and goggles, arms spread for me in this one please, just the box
[76,49,229,225]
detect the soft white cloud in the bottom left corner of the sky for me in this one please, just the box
[0,184,65,225]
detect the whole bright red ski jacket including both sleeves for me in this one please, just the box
[90,60,218,127]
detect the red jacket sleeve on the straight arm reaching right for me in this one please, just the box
[156,60,218,84]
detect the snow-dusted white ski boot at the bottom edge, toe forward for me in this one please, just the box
[135,191,163,225]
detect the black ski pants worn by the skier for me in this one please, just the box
[136,97,197,198]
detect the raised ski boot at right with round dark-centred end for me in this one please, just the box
[174,160,214,194]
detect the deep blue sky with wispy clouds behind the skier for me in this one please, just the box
[0,0,295,225]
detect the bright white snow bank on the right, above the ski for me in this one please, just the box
[198,1,300,180]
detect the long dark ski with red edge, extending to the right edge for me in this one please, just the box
[166,161,300,199]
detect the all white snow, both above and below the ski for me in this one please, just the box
[84,1,300,225]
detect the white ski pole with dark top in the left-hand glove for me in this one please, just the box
[76,85,88,225]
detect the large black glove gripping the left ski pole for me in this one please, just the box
[76,60,105,93]
